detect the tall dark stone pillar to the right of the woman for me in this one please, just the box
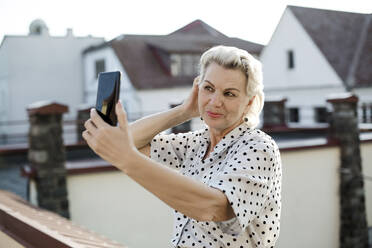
[327,94,368,248]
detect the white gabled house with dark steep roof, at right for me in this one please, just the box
[260,6,372,125]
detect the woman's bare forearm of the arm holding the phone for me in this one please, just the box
[118,150,234,221]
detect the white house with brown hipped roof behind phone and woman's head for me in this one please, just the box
[83,20,263,129]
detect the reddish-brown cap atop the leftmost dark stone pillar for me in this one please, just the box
[27,101,68,115]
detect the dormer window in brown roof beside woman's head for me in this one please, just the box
[170,54,200,76]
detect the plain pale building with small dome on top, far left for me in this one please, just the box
[0,20,104,142]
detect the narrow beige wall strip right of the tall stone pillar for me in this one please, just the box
[360,142,372,227]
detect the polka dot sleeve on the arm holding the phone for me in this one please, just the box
[210,136,279,230]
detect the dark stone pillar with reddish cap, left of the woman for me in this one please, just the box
[27,102,70,218]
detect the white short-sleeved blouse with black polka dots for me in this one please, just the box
[151,123,282,248]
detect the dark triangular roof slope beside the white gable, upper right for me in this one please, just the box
[288,7,370,82]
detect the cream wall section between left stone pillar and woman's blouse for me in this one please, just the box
[67,172,173,248]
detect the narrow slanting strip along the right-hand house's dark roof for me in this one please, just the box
[345,14,372,90]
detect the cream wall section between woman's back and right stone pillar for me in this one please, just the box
[275,147,340,248]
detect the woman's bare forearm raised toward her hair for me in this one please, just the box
[129,105,191,149]
